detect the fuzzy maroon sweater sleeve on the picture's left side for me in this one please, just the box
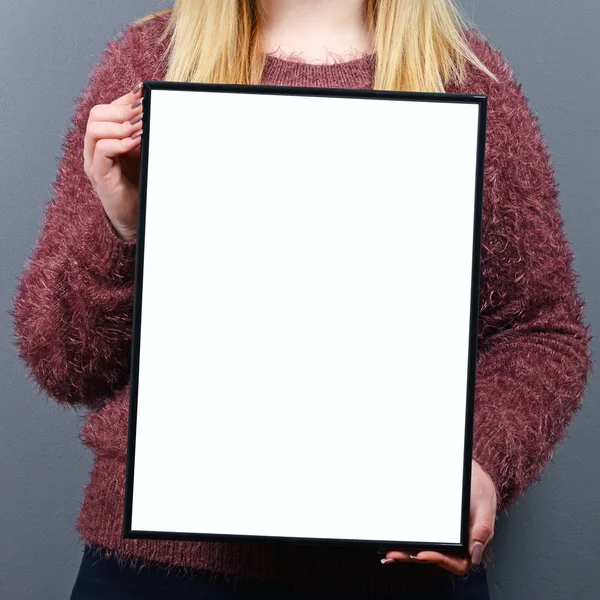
[9,23,145,408]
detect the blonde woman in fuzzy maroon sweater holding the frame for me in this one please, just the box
[13,0,591,600]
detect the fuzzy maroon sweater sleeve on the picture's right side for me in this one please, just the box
[473,41,593,511]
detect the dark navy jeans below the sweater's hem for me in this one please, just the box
[70,546,490,600]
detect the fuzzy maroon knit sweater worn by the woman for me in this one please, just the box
[11,11,592,588]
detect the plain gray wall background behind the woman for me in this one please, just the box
[0,0,600,600]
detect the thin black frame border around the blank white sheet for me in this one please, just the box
[123,80,488,553]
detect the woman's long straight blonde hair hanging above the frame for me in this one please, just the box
[134,0,497,92]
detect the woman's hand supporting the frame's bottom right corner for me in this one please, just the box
[379,460,497,575]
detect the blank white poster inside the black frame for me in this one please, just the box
[131,89,480,544]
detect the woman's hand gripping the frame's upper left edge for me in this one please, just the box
[83,83,143,242]
